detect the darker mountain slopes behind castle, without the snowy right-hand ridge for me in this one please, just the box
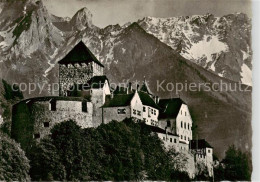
[0,1,251,156]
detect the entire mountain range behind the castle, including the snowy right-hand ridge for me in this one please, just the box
[0,0,252,156]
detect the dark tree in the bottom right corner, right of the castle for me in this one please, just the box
[222,145,251,181]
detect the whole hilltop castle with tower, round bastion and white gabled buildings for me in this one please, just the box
[11,42,213,177]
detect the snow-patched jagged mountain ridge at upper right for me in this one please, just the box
[138,13,252,85]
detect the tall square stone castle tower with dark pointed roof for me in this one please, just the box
[58,41,104,96]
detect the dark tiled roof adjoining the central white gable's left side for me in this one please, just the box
[103,93,134,107]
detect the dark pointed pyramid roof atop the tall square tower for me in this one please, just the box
[58,41,104,67]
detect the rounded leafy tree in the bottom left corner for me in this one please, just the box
[0,132,30,181]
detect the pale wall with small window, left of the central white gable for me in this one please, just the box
[103,106,131,124]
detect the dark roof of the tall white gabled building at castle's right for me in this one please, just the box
[158,98,185,118]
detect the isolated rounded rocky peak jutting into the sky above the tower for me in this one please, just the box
[70,7,93,31]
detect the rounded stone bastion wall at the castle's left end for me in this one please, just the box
[11,97,94,148]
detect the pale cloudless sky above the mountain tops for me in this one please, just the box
[43,0,252,28]
